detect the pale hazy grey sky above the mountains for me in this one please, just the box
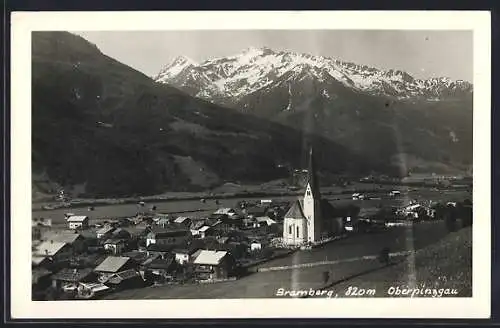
[75,30,473,82]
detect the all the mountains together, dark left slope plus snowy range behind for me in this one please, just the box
[32,32,472,197]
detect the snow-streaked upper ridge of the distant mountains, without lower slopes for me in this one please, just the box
[155,47,472,105]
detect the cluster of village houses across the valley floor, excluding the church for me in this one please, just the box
[32,188,472,300]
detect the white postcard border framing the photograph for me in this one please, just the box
[10,11,491,319]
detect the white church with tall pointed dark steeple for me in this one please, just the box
[283,148,351,246]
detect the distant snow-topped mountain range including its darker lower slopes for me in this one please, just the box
[154,47,473,177]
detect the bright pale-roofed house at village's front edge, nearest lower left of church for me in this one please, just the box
[193,250,235,280]
